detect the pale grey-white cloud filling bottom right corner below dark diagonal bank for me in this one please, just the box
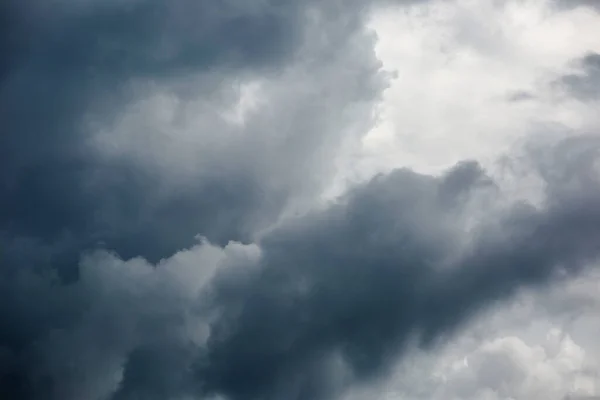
[346,271,600,400]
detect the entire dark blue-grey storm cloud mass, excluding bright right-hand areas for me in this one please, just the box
[0,0,600,400]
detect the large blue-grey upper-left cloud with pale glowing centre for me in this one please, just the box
[0,1,385,270]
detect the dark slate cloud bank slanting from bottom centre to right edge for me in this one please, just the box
[198,138,600,399]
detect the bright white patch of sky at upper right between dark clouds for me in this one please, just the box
[354,0,600,177]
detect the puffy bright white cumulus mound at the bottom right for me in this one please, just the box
[360,329,598,400]
